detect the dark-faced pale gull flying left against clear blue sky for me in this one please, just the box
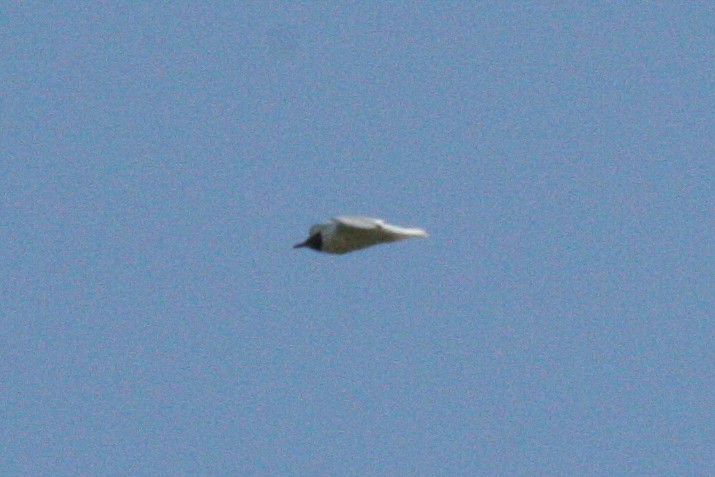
[293,216,427,255]
